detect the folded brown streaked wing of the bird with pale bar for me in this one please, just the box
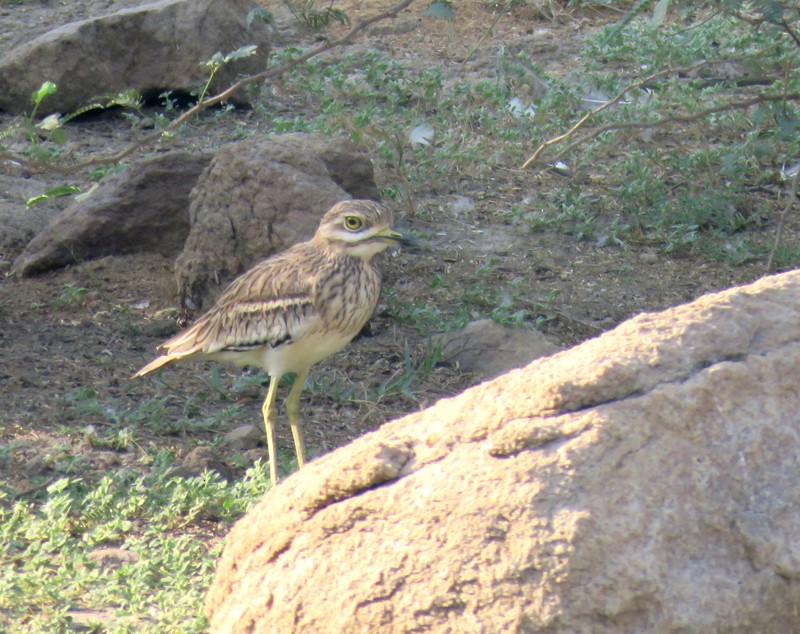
[159,244,319,359]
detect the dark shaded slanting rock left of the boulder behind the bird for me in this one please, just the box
[14,150,211,276]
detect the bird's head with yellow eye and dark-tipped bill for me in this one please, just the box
[314,200,416,260]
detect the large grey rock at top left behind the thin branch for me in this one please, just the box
[0,0,270,115]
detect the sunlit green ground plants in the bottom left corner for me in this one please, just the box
[0,452,269,633]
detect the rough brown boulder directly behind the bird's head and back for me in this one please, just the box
[175,133,378,309]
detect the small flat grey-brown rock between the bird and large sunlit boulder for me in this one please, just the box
[435,319,558,379]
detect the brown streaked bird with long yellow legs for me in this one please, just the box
[132,200,418,486]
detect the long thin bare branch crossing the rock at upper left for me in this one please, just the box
[0,0,414,174]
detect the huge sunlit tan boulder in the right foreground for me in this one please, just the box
[207,272,800,634]
